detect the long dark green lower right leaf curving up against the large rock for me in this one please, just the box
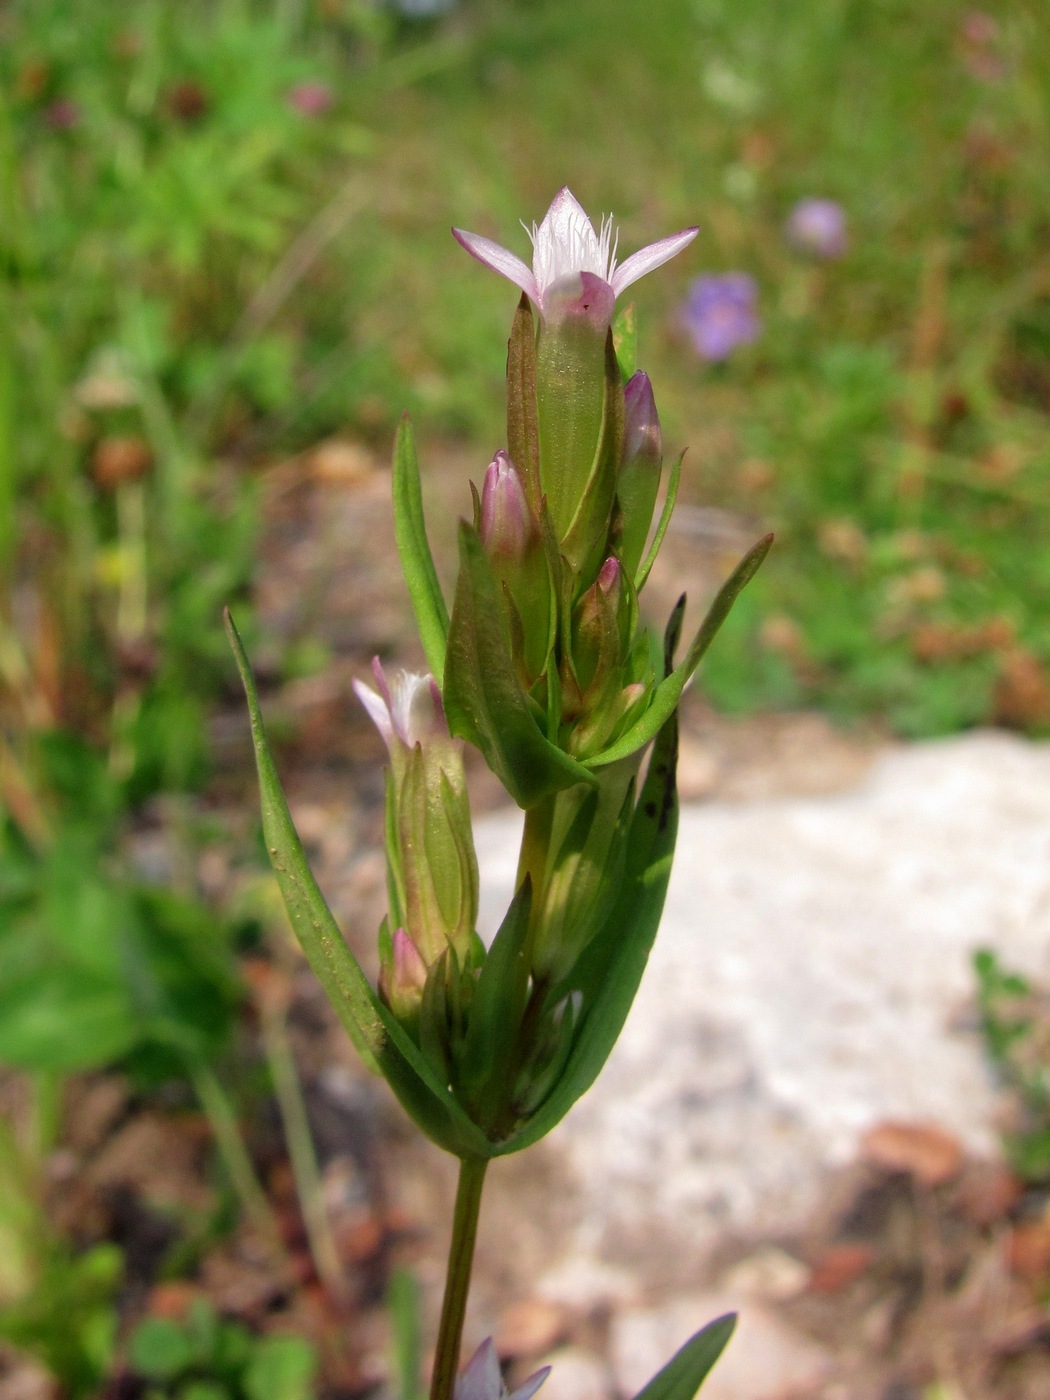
[497,672,678,1155]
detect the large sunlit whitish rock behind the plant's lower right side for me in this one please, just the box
[477,732,1050,1257]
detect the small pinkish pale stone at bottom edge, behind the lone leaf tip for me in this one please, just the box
[609,1294,833,1400]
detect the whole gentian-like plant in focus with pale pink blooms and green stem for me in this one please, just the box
[230,189,771,1400]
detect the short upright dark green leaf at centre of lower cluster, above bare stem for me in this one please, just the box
[458,875,532,1127]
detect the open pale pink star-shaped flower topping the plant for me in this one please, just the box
[452,185,699,322]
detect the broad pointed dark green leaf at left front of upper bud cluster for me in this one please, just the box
[442,521,595,808]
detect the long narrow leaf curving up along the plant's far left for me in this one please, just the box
[225,612,491,1156]
